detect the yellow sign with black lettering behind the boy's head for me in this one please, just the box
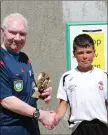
[83,32,105,70]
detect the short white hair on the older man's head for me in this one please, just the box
[1,13,28,30]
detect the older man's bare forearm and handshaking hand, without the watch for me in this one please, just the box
[0,96,52,123]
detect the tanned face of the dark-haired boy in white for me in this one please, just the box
[74,46,95,69]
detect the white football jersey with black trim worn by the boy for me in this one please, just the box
[57,67,108,131]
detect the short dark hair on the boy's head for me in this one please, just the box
[73,34,94,52]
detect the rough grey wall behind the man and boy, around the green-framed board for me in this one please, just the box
[1,0,108,134]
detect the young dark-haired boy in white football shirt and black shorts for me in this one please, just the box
[53,34,108,135]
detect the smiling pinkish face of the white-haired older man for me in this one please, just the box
[2,16,26,53]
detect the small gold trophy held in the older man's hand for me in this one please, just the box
[32,72,51,98]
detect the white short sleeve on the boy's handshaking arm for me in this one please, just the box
[57,75,68,101]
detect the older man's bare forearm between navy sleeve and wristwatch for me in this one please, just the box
[1,96,36,117]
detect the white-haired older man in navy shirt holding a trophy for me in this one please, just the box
[0,13,55,135]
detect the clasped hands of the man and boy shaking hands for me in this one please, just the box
[39,110,61,130]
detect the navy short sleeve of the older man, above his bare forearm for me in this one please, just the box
[0,59,12,98]
